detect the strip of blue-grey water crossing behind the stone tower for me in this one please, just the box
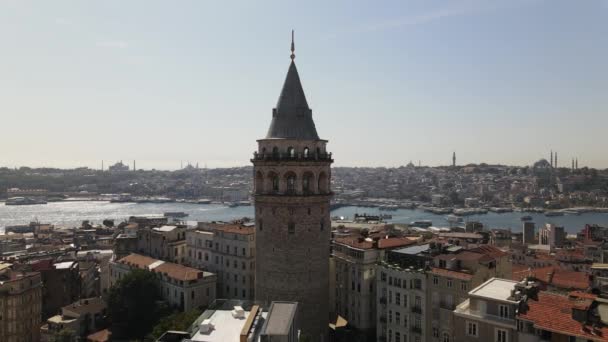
[0,201,608,233]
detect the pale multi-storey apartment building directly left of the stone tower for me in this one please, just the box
[186,223,255,300]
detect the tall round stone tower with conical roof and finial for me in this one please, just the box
[251,33,333,341]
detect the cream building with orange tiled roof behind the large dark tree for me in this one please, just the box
[110,254,216,311]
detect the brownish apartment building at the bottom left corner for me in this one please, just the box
[0,263,42,342]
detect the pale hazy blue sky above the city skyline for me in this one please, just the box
[0,0,608,169]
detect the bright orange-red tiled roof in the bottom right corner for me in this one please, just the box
[519,292,608,341]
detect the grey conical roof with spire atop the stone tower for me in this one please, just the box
[266,32,319,140]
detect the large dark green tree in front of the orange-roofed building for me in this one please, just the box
[108,270,168,339]
